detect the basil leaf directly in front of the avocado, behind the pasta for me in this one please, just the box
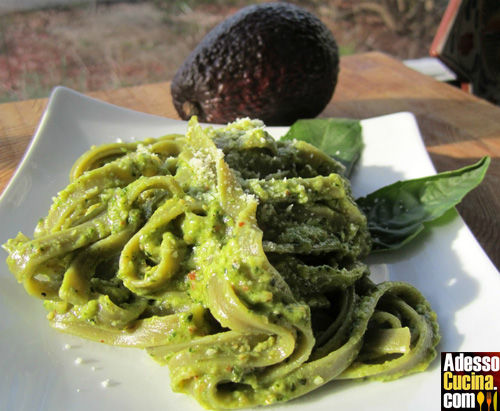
[281,118,363,177]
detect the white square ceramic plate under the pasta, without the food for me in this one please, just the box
[0,88,500,411]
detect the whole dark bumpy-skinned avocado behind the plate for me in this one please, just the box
[171,3,339,125]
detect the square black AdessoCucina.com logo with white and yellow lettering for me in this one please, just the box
[441,352,500,411]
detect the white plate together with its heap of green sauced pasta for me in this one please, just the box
[0,87,500,410]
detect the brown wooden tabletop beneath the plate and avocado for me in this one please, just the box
[0,53,500,268]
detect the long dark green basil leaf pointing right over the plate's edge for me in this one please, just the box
[356,157,490,251]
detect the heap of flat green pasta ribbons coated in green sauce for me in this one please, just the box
[4,119,439,408]
